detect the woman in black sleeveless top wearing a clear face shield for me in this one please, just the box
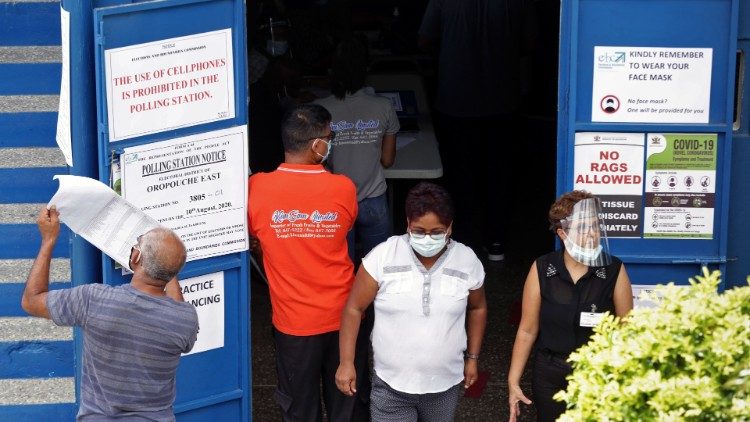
[508,191,633,422]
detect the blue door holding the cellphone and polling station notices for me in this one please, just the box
[93,0,250,421]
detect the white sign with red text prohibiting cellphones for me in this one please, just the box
[104,29,235,142]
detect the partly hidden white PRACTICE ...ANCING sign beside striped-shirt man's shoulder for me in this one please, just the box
[180,272,224,356]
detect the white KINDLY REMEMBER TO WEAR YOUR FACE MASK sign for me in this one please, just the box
[591,46,713,123]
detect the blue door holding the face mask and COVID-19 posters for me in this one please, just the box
[557,0,747,284]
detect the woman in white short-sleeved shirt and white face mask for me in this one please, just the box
[336,182,487,422]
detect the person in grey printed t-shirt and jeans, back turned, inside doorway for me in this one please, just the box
[316,38,399,262]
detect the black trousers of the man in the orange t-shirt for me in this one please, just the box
[273,328,369,422]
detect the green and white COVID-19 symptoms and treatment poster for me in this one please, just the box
[643,133,718,239]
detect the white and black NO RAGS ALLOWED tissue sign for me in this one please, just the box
[573,132,644,238]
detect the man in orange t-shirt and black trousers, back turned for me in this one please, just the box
[248,105,367,422]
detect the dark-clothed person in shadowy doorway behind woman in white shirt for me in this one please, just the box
[418,0,525,261]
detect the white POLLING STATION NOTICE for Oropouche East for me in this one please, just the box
[120,126,248,261]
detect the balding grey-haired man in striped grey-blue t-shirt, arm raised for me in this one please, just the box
[21,206,198,422]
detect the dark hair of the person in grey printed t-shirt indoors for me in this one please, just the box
[331,36,369,100]
